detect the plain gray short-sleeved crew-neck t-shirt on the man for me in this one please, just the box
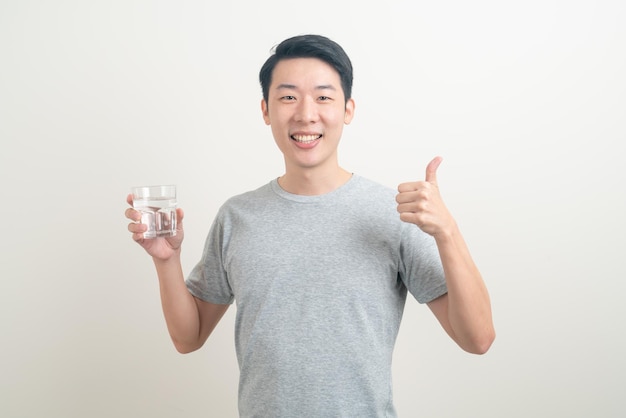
[187,175,447,418]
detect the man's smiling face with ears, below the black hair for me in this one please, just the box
[261,58,354,171]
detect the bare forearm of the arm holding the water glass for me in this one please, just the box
[154,254,204,353]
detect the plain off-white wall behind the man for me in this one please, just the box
[0,0,626,418]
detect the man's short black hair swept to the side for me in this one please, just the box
[259,35,353,102]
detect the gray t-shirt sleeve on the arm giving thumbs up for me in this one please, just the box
[400,223,448,303]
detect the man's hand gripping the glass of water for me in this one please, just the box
[125,194,185,260]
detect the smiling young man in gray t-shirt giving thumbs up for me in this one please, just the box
[126,35,494,418]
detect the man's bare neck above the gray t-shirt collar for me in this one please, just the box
[278,167,352,196]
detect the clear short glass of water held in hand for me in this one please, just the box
[131,185,176,238]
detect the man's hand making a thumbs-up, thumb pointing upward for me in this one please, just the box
[396,157,455,237]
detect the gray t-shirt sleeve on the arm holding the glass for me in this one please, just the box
[185,216,234,304]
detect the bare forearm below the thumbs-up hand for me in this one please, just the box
[435,224,495,353]
